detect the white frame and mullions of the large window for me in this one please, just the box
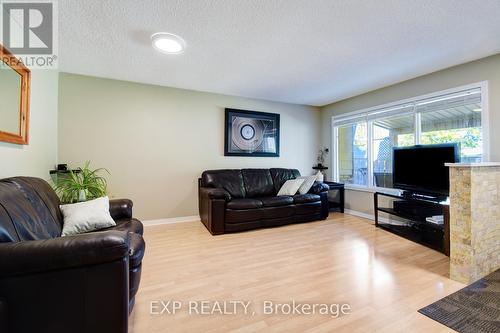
[331,81,490,192]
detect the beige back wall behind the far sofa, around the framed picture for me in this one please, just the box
[59,73,320,219]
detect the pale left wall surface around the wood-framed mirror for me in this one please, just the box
[0,70,58,179]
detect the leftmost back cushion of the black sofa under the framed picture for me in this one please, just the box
[201,169,246,198]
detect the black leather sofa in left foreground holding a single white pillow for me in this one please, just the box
[0,177,145,333]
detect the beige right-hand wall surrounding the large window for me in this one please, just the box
[321,54,500,214]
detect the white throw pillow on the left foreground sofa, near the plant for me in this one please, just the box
[60,197,116,236]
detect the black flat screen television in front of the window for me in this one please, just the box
[392,143,460,196]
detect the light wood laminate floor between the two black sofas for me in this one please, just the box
[129,213,464,333]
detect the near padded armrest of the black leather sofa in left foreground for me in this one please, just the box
[0,231,129,277]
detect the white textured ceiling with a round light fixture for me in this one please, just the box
[59,0,500,105]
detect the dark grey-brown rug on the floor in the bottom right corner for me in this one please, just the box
[418,269,500,333]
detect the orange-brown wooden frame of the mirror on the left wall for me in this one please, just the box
[0,44,31,145]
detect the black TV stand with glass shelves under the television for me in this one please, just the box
[373,192,450,256]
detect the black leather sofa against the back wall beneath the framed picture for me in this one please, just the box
[198,168,329,235]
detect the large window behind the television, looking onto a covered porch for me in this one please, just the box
[333,85,486,188]
